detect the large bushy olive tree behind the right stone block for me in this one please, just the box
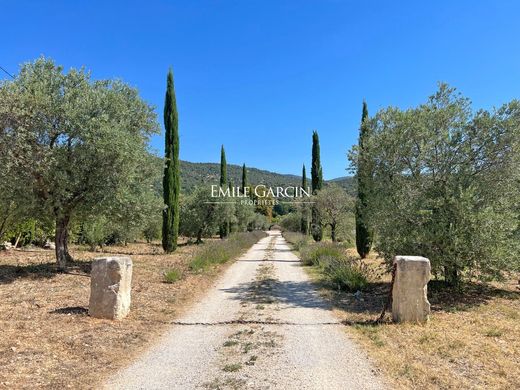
[350,84,520,284]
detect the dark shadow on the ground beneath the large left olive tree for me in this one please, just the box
[0,261,91,284]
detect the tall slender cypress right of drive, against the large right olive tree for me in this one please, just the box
[356,101,373,259]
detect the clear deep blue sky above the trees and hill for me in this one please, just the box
[0,0,520,179]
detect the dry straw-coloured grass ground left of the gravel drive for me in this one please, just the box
[0,239,242,389]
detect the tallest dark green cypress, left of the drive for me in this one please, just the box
[162,69,181,253]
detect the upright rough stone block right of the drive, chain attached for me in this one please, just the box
[392,256,430,322]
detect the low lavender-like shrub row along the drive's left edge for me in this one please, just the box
[189,230,266,272]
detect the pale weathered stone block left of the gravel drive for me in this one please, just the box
[89,257,132,320]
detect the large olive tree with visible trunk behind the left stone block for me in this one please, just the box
[0,58,158,269]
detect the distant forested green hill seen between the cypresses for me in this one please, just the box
[173,161,355,193]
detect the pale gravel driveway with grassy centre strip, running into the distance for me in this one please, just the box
[107,232,384,390]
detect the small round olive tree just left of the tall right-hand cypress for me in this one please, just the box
[313,184,354,242]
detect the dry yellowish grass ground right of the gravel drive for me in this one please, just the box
[306,250,520,389]
